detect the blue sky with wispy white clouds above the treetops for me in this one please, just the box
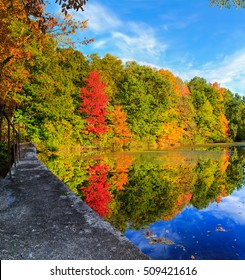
[51,0,245,95]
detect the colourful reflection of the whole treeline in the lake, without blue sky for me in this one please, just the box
[40,148,245,231]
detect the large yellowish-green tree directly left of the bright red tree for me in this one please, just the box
[15,35,85,151]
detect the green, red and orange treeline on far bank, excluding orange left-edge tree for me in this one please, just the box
[8,48,245,152]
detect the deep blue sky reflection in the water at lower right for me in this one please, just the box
[125,184,245,260]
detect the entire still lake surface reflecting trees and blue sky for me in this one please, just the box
[42,146,245,260]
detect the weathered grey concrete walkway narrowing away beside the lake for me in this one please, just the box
[0,143,148,260]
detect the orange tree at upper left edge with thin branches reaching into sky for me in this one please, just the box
[0,0,91,107]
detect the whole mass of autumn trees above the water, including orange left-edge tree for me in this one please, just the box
[0,0,245,159]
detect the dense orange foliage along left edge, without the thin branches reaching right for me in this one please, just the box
[0,0,40,103]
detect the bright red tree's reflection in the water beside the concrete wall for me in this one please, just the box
[81,164,111,217]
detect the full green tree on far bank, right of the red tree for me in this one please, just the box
[116,62,171,148]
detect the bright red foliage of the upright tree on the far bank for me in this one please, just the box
[79,71,109,135]
